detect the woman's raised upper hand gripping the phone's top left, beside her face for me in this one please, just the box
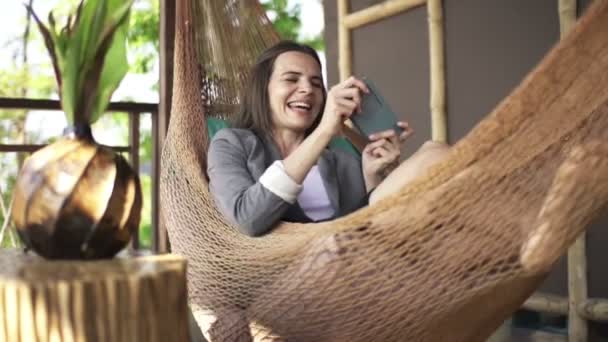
[318,76,369,136]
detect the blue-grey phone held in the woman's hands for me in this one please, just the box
[350,79,403,137]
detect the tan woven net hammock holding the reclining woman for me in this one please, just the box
[160,0,608,341]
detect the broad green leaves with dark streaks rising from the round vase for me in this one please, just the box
[26,0,133,124]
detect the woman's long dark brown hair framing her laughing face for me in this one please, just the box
[233,41,327,135]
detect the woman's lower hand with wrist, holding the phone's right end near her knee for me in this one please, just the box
[361,121,414,192]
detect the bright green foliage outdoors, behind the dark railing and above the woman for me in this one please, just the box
[0,0,324,247]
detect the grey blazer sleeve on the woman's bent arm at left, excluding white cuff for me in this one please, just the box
[207,129,290,236]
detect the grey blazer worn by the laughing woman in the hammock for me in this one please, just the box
[207,128,367,236]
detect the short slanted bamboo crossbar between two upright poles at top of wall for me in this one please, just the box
[342,0,426,29]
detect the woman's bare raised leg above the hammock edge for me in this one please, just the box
[369,141,450,204]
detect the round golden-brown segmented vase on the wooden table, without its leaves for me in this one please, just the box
[12,125,142,259]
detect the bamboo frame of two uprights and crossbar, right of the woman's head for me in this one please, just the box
[338,0,448,142]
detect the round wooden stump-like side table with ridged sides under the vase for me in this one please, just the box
[0,249,190,342]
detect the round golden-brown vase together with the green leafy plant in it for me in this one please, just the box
[12,0,142,259]
